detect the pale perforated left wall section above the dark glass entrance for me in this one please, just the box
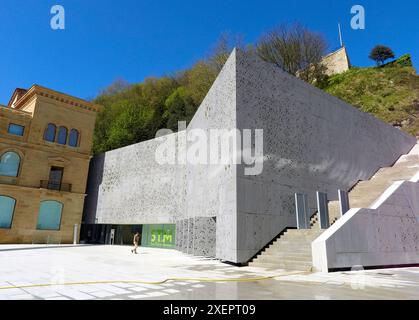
[85,132,185,224]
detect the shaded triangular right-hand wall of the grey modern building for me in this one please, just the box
[236,51,416,262]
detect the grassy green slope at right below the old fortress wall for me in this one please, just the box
[322,55,419,136]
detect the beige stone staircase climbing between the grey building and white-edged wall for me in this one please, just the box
[249,144,419,271]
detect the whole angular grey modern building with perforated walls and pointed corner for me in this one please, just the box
[83,50,419,270]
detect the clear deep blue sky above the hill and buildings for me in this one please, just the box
[0,0,419,104]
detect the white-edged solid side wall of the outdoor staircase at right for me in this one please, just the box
[312,174,419,272]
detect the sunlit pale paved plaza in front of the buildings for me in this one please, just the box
[0,245,419,300]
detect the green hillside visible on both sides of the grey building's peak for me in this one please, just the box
[93,50,419,154]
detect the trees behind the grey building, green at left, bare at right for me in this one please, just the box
[93,24,334,154]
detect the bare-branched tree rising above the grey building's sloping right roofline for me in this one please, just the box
[256,23,327,82]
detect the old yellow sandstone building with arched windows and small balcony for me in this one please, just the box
[0,85,99,243]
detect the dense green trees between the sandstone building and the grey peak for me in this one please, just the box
[93,37,231,154]
